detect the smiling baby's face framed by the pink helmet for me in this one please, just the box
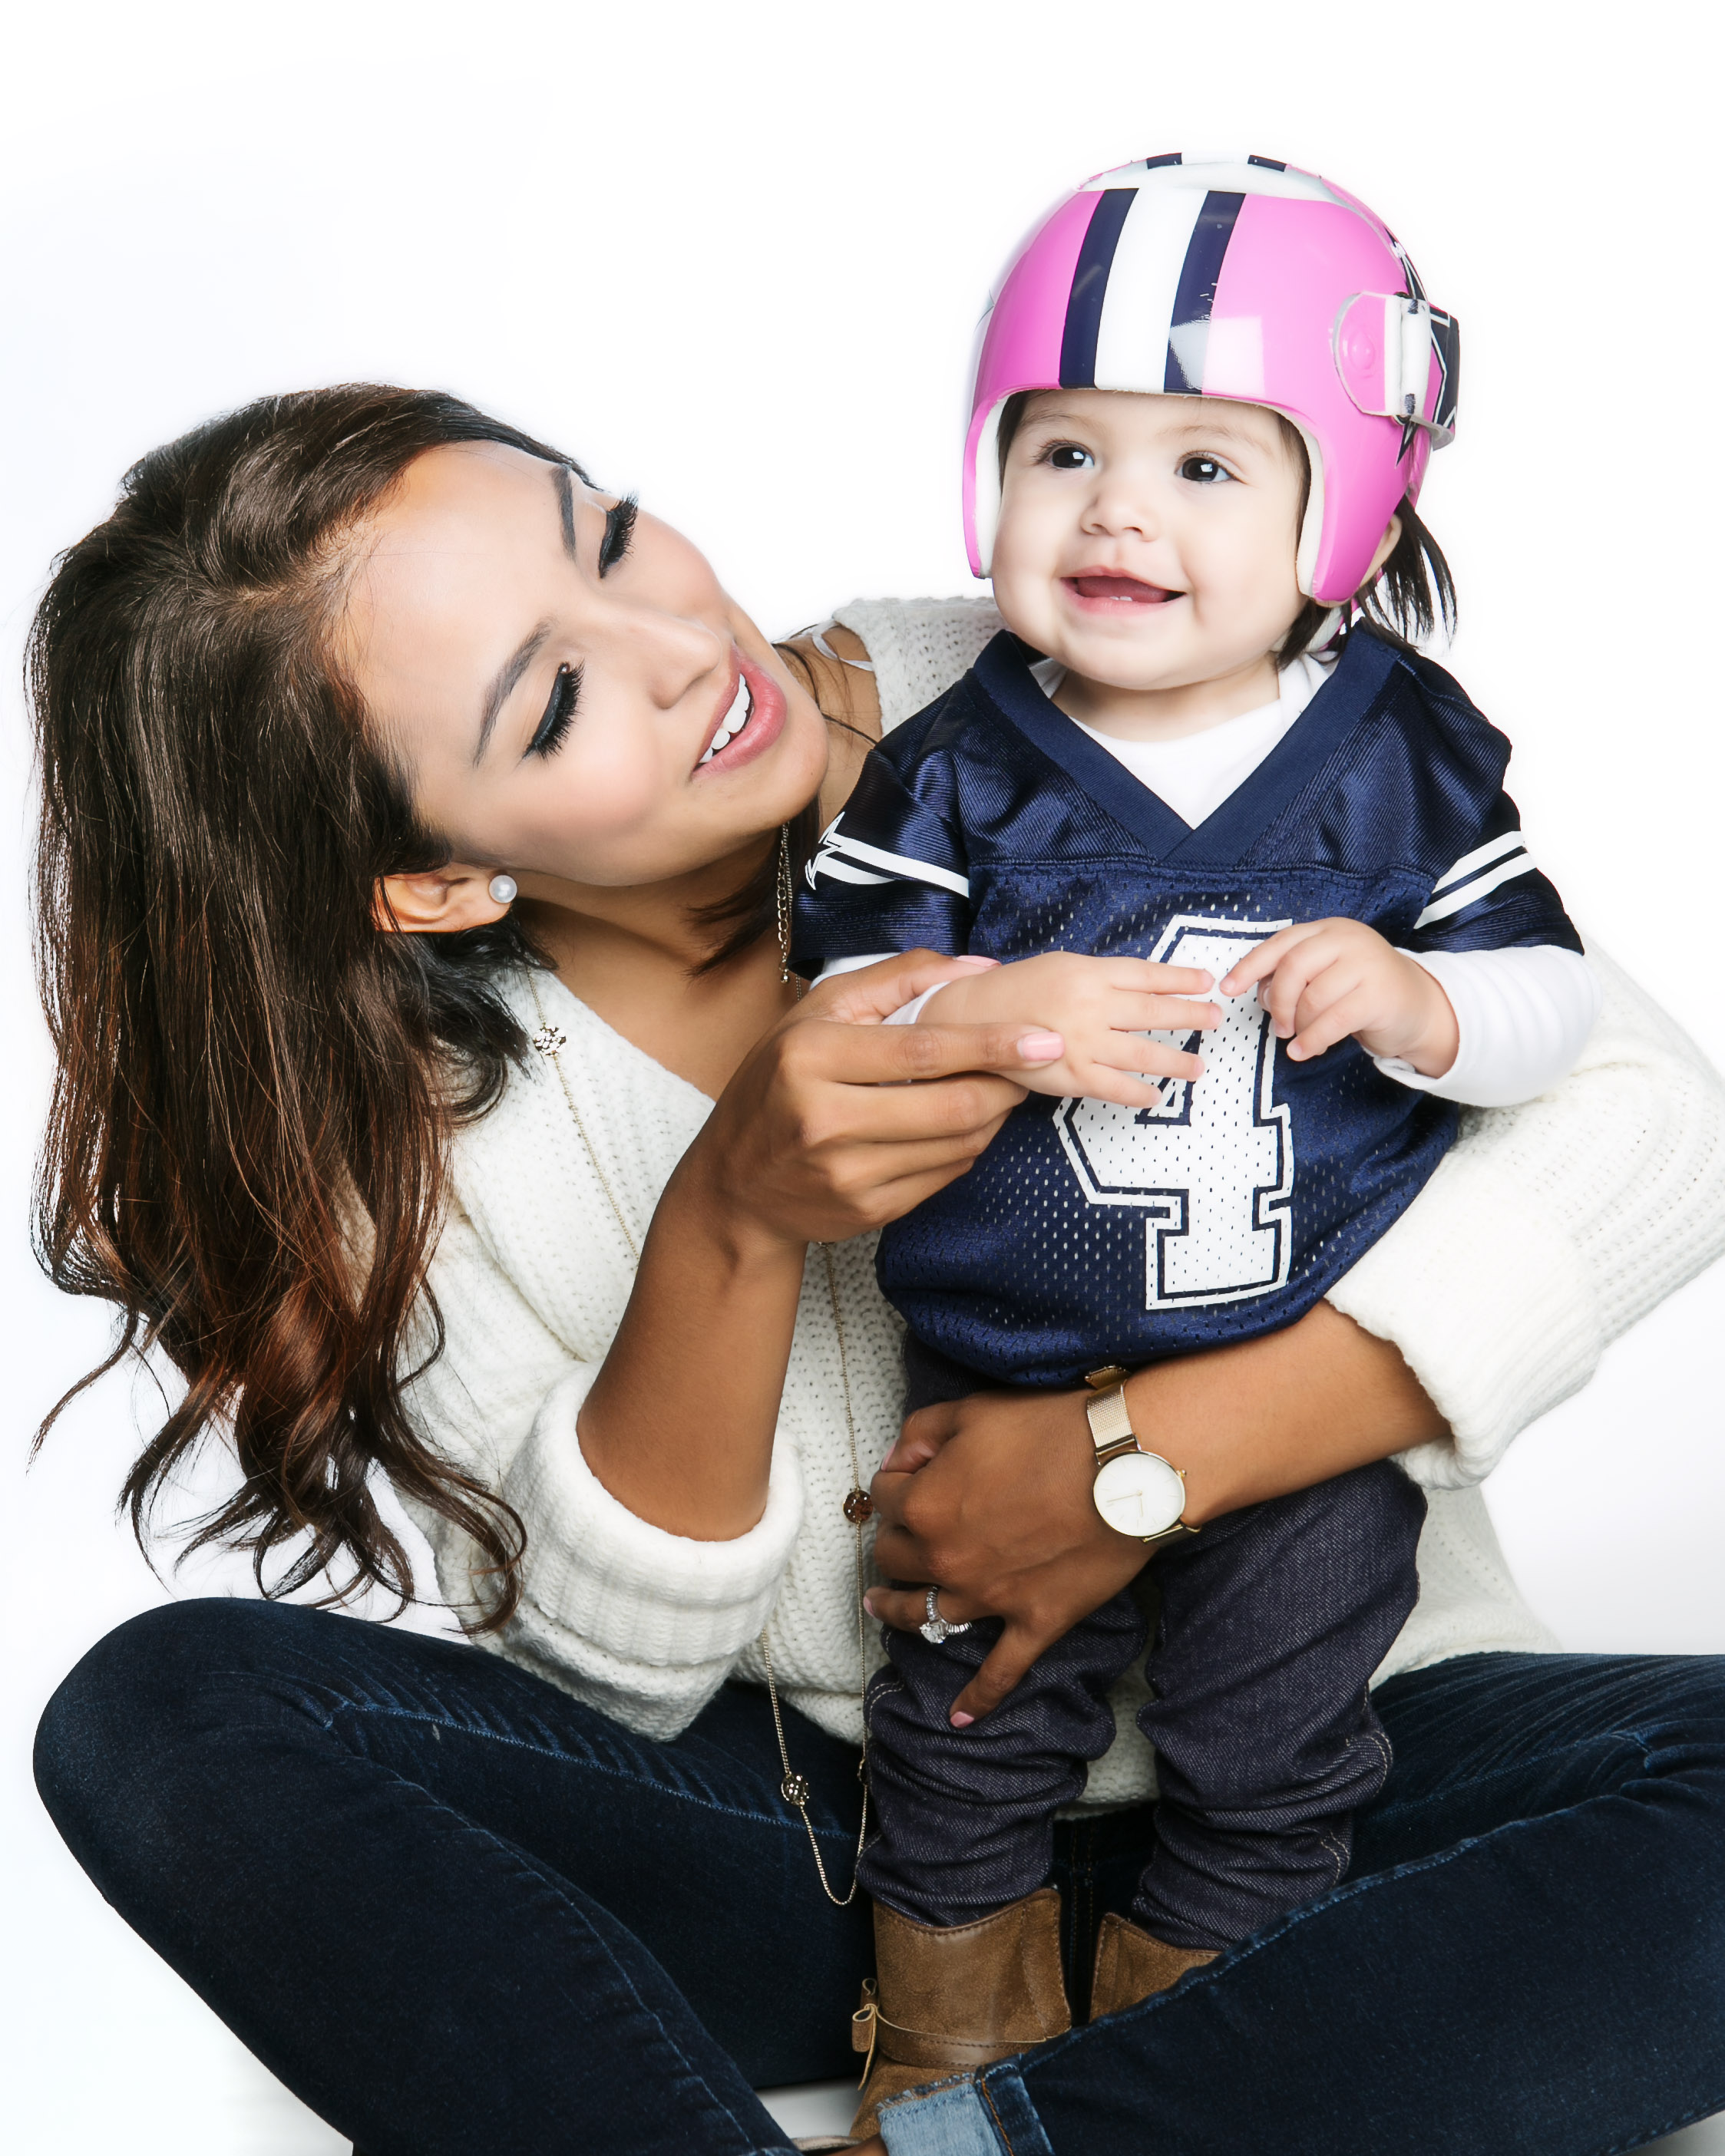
[994,390,1304,690]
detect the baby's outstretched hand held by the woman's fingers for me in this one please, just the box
[919,951,1223,1108]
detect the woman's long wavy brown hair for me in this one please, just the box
[28,386,612,1626]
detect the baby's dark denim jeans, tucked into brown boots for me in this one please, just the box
[863,1359,1426,1947]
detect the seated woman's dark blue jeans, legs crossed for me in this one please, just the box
[37,1602,1725,2156]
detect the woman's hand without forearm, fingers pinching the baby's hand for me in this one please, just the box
[675,951,1063,1250]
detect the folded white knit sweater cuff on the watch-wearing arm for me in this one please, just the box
[1328,1151,1604,1490]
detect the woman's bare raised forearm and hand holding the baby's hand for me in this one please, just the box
[578,951,1063,1541]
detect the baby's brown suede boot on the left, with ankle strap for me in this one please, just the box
[850,1887,1072,2141]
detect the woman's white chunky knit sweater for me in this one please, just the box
[401,599,1725,1804]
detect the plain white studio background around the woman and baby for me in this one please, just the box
[0,0,1725,2156]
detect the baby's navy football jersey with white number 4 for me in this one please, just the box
[794,627,1581,1384]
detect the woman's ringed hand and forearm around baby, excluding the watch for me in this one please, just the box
[869,1302,1447,1727]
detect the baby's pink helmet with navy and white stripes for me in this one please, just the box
[964,151,1460,606]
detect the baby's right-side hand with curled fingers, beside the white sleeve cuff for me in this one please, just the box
[1223,920,1462,1078]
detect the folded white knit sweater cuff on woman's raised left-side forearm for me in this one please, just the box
[491,1365,802,1669]
